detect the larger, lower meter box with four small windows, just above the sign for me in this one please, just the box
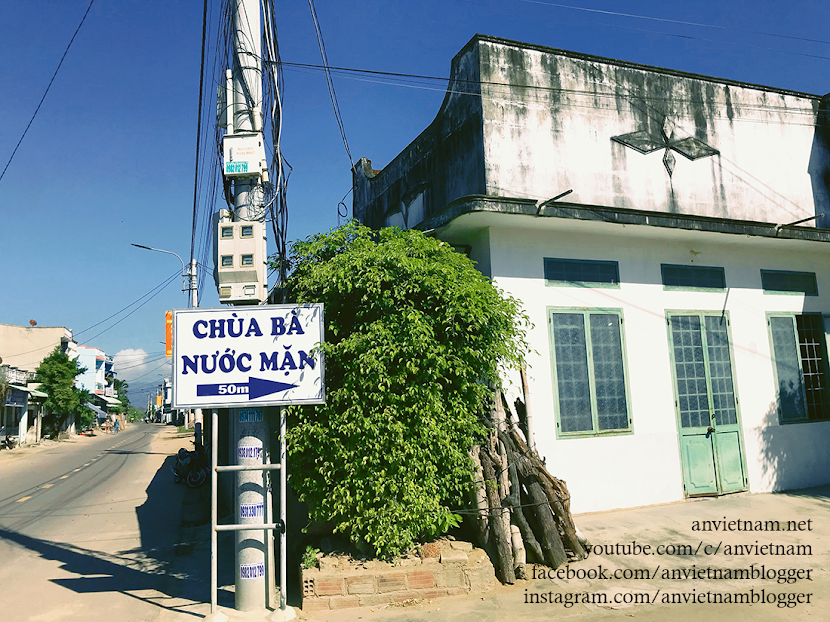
[213,210,268,305]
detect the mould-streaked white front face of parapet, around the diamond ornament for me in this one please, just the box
[479,40,830,226]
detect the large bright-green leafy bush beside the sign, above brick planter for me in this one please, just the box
[278,221,527,557]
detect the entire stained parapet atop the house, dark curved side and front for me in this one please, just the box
[354,36,830,234]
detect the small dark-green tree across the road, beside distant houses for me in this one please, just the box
[35,348,88,433]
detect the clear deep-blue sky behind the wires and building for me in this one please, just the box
[0,0,830,407]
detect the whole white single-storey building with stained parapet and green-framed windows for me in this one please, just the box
[354,36,830,512]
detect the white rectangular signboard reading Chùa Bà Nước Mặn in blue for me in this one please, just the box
[173,304,325,408]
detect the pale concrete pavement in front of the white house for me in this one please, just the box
[301,486,830,622]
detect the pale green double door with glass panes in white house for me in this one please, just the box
[667,312,746,496]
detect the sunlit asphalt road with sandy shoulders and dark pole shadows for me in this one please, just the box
[0,423,204,622]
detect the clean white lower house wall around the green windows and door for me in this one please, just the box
[484,222,830,512]
